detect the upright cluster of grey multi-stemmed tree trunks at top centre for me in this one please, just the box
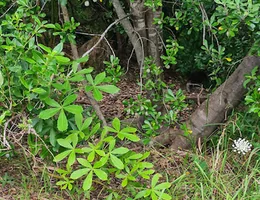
[112,0,162,67]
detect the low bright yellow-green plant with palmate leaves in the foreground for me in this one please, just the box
[54,118,172,197]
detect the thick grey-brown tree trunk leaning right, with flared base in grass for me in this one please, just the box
[151,56,260,149]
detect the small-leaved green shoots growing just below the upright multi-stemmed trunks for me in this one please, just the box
[123,58,187,144]
